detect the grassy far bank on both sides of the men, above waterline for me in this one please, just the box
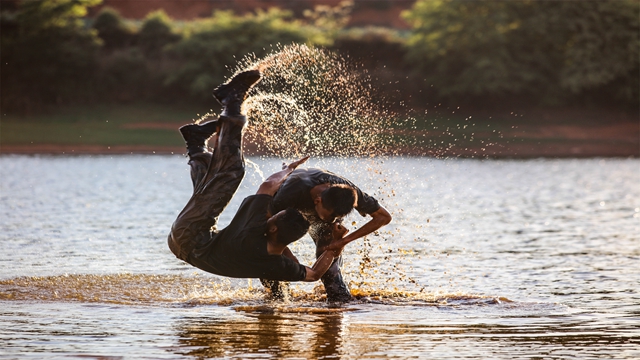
[0,104,640,158]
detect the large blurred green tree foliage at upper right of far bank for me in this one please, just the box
[403,0,639,107]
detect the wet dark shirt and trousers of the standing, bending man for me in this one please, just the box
[263,169,380,301]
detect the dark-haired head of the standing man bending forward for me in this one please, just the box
[314,184,358,222]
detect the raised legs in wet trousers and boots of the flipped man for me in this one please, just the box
[169,69,260,262]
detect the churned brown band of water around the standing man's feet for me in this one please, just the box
[0,273,510,313]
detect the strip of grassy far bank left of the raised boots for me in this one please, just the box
[0,105,206,153]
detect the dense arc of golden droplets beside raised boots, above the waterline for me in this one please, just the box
[232,45,400,158]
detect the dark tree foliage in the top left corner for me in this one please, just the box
[0,0,100,112]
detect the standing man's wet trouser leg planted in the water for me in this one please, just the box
[309,221,351,302]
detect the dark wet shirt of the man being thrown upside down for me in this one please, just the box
[189,194,307,281]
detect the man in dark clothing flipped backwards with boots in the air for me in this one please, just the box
[168,70,347,281]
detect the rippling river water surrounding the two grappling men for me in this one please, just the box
[0,155,640,359]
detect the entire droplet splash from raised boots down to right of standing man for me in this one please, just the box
[188,45,502,291]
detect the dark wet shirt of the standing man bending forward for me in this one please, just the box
[271,168,380,216]
